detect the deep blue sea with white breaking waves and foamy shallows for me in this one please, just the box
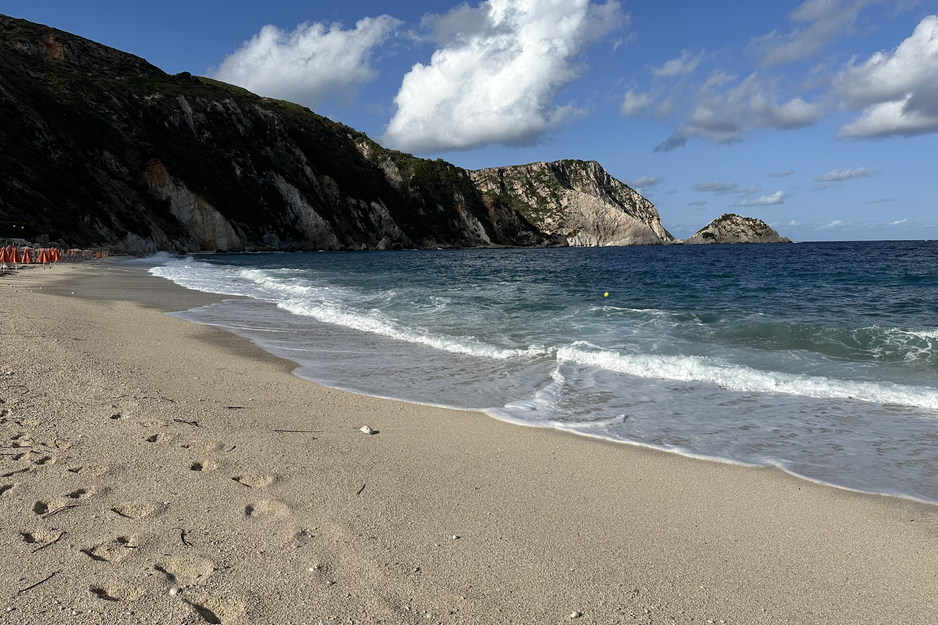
[151,241,938,502]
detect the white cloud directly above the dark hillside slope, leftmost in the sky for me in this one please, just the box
[209,15,401,106]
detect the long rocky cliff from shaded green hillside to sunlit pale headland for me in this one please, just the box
[0,16,671,253]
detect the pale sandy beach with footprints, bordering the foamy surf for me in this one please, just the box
[0,261,938,625]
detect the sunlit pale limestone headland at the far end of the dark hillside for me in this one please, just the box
[470,160,674,246]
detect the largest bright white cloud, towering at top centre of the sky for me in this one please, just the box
[384,0,628,153]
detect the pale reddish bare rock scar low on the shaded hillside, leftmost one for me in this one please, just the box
[144,159,244,252]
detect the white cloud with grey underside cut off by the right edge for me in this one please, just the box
[834,15,938,139]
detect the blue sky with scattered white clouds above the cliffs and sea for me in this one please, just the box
[7,0,938,241]
